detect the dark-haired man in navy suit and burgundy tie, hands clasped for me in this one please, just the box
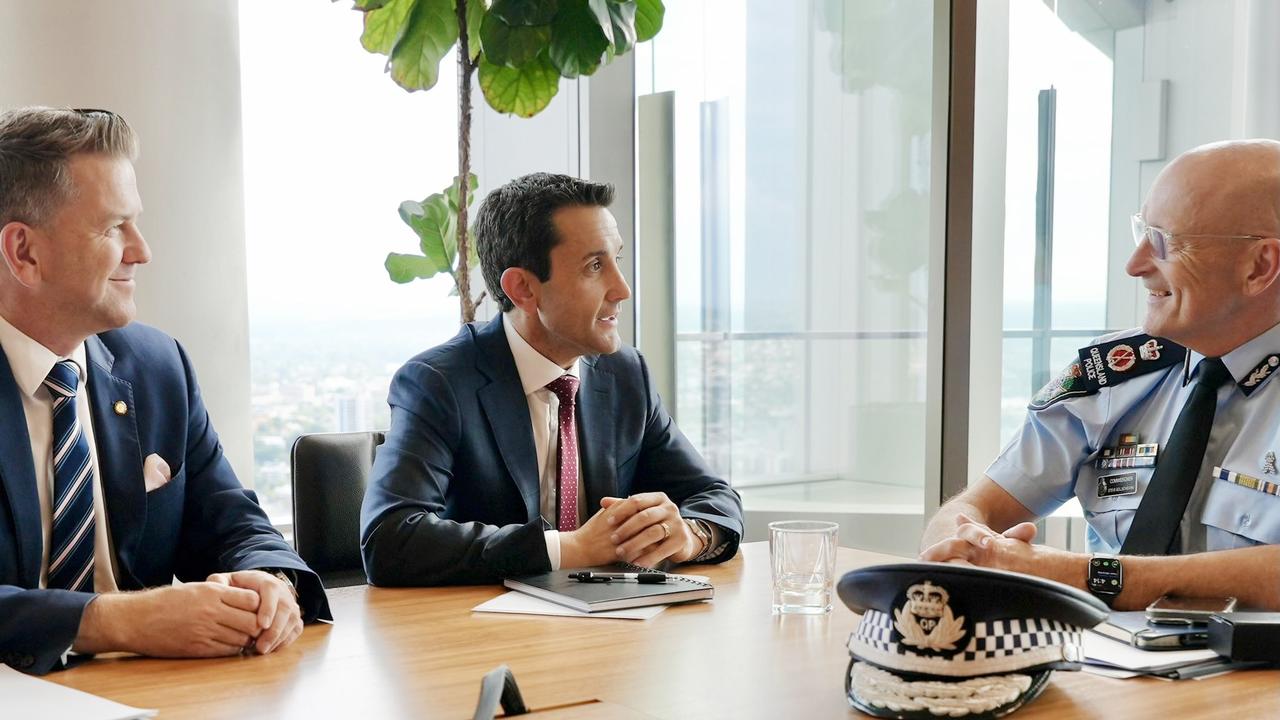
[361,173,742,585]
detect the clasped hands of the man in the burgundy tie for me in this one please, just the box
[561,492,701,568]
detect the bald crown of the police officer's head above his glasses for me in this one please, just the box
[1143,134,1280,237]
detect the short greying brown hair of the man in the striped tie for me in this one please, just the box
[0,108,138,227]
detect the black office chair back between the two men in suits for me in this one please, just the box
[289,432,385,588]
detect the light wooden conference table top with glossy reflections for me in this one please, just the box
[47,543,1280,720]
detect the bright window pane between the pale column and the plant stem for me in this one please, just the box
[239,0,458,515]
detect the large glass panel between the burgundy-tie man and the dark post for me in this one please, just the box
[637,0,937,527]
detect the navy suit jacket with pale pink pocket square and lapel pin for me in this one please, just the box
[0,323,330,673]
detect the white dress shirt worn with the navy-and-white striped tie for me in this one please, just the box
[0,316,119,592]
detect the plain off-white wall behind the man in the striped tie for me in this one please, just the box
[0,0,253,484]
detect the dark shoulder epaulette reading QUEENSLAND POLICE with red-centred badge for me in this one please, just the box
[1028,334,1187,410]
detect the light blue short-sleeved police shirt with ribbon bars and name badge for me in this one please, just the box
[987,325,1280,553]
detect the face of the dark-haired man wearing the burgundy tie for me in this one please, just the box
[524,205,631,366]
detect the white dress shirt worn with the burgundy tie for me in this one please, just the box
[502,314,595,570]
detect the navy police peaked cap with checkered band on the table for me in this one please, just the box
[838,562,1107,720]
